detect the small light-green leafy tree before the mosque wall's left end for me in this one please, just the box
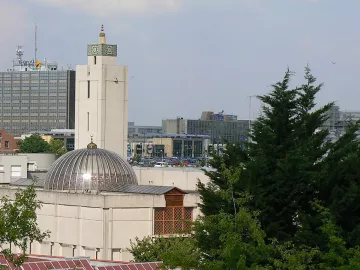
[0,185,50,266]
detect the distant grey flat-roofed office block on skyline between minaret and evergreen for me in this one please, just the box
[162,112,249,144]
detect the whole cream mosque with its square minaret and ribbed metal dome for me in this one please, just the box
[0,27,204,261]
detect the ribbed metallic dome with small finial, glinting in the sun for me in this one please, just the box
[44,142,138,191]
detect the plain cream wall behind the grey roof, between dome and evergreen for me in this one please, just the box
[134,167,210,191]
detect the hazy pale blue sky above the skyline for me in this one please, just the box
[0,0,360,125]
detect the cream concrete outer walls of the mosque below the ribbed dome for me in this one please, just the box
[0,188,199,261]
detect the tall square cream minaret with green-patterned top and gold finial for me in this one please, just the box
[75,25,128,158]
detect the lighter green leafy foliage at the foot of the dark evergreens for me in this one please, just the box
[194,196,360,270]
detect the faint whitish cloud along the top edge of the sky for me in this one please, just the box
[30,0,181,17]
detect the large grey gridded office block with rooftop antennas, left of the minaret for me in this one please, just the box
[0,46,75,136]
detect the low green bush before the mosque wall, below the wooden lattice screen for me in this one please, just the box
[129,237,200,270]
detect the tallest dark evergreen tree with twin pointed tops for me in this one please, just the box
[246,67,333,241]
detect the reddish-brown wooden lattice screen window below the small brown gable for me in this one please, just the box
[154,207,193,235]
